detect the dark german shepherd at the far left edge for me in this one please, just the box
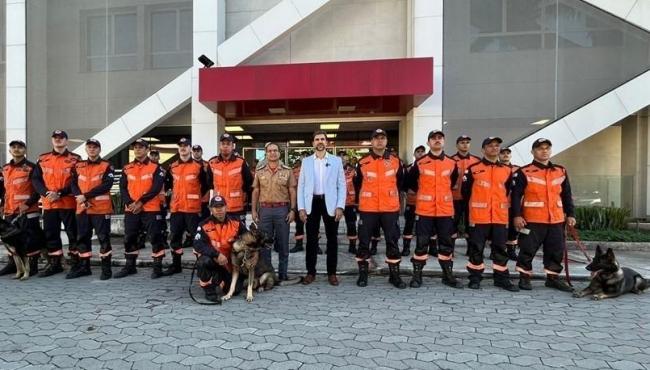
[0,215,45,280]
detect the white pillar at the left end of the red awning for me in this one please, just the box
[192,0,226,159]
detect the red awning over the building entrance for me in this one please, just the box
[199,58,433,119]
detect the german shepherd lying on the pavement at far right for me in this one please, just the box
[573,245,648,300]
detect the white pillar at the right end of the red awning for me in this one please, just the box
[400,0,443,159]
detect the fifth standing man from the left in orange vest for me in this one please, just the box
[163,137,208,275]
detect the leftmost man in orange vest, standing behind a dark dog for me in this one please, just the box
[0,140,43,276]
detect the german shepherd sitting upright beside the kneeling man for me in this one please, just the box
[222,224,278,303]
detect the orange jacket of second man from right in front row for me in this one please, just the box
[462,159,512,226]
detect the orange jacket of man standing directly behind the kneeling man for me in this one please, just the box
[208,154,253,212]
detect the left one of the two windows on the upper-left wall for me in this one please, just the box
[82,9,138,72]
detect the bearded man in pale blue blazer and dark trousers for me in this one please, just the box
[298,131,346,286]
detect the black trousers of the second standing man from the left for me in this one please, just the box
[43,209,77,256]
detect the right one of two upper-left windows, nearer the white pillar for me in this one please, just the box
[148,3,192,69]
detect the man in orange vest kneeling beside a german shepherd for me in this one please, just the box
[194,195,246,303]
